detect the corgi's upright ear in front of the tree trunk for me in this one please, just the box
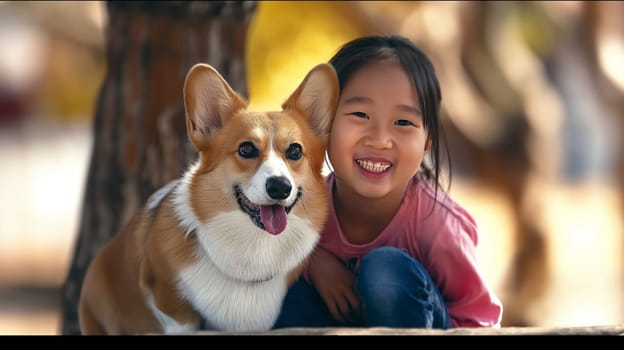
[183,63,247,151]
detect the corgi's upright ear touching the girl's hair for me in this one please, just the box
[282,63,340,138]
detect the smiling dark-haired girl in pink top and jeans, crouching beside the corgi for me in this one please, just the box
[274,36,502,329]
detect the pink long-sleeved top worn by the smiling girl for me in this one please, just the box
[305,173,503,327]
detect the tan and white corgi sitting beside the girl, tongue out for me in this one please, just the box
[78,63,339,335]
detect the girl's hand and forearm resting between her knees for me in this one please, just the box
[308,247,360,322]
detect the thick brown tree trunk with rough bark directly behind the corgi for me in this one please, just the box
[60,1,256,335]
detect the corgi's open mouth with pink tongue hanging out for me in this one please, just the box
[234,186,301,235]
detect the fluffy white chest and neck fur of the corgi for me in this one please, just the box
[167,185,319,331]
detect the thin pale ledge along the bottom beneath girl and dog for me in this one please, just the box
[193,325,624,335]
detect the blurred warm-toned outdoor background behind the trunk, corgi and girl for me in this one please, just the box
[0,1,624,334]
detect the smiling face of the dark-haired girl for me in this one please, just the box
[328,61,431,199]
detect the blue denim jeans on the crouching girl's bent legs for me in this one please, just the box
[273,247,451,329]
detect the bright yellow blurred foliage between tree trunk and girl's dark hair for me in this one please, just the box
[247,1,368,109]
